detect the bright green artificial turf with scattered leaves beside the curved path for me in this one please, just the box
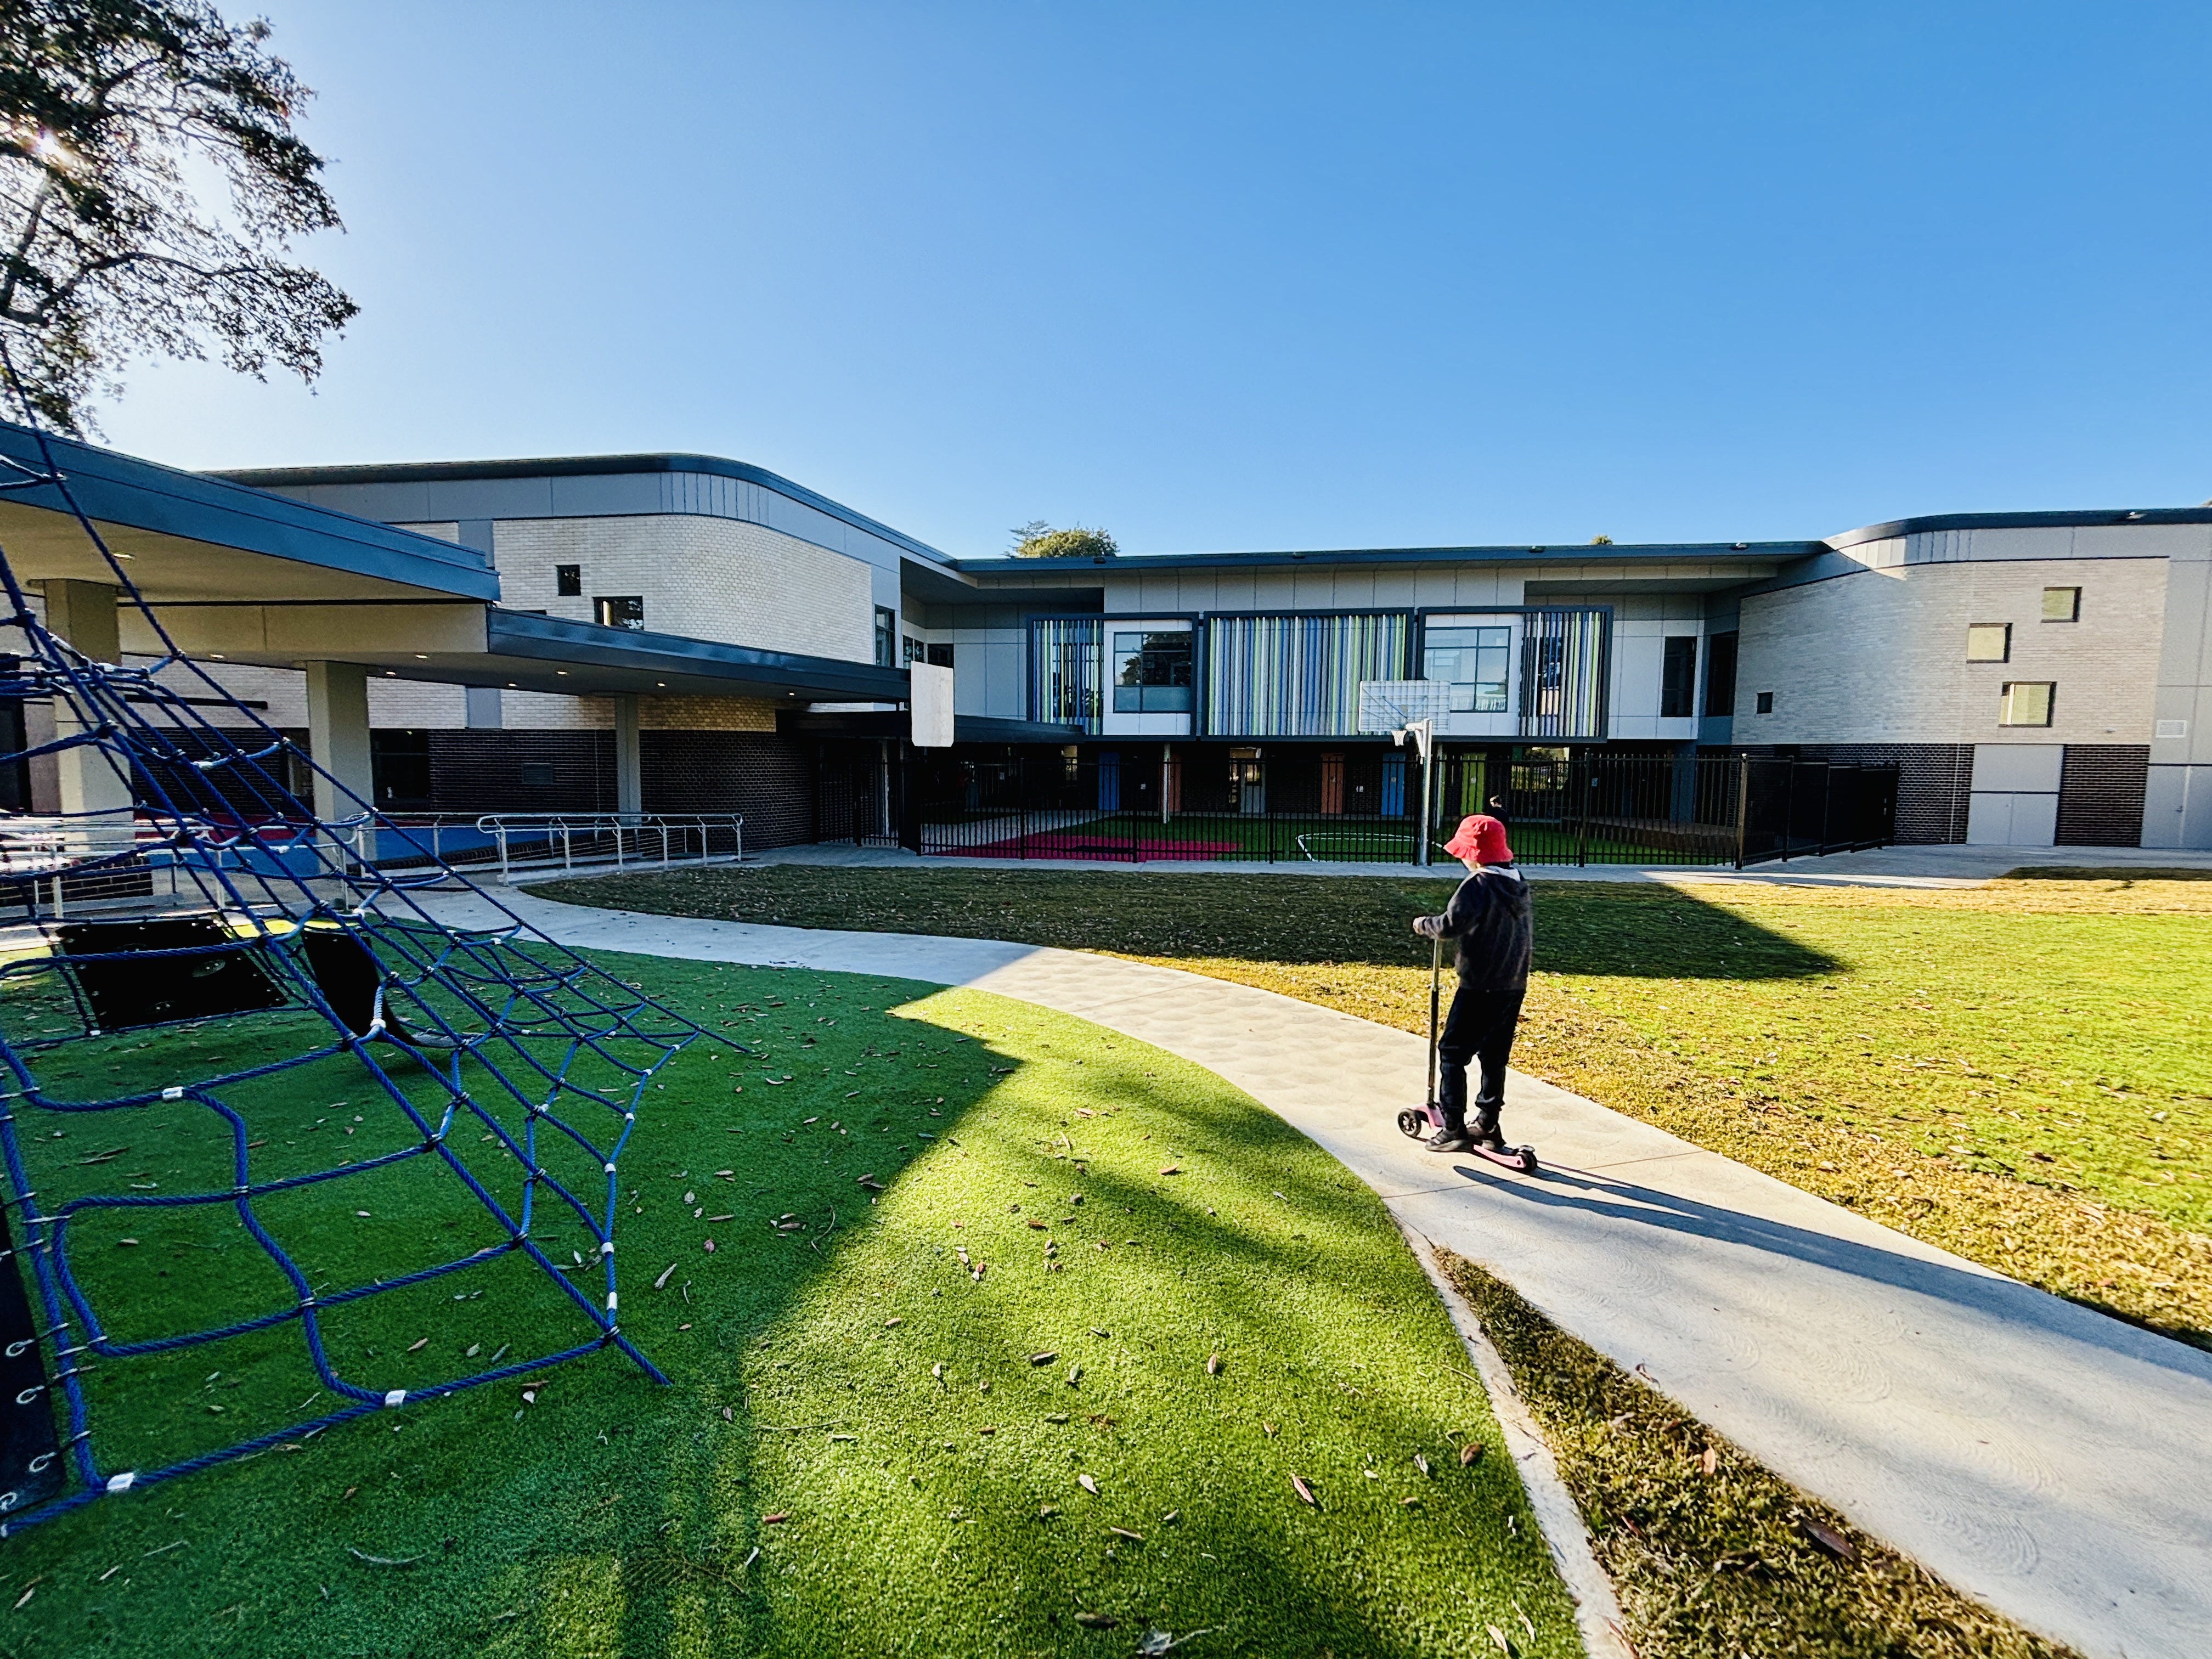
[0,958,1579,1659]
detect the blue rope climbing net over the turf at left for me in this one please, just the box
[0,400,735,1537]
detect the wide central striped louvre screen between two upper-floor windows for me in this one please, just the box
[1205,611,1413,737]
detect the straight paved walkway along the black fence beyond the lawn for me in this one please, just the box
[747,840,2212,889]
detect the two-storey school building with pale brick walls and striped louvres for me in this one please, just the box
[0,416,2212,847]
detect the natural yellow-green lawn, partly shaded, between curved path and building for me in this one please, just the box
[538,865,2212,1345]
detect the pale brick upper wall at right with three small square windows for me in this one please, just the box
[1734,557,2165,743]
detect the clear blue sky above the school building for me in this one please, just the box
[104,0,2212,555]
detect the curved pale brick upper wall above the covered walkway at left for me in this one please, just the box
[491,513,876,662]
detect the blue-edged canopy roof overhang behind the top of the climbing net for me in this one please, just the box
[0,422,500,604]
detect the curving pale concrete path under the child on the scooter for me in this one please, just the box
[431,894,2212,1659]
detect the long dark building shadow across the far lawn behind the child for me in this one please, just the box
[533,865,1843,980]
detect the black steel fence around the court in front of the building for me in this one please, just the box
[816,748,1898,867]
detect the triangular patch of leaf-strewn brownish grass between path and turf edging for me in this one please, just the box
[1438,1250,2073,1659]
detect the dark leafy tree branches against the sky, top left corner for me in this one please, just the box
[0,0,358,431]
